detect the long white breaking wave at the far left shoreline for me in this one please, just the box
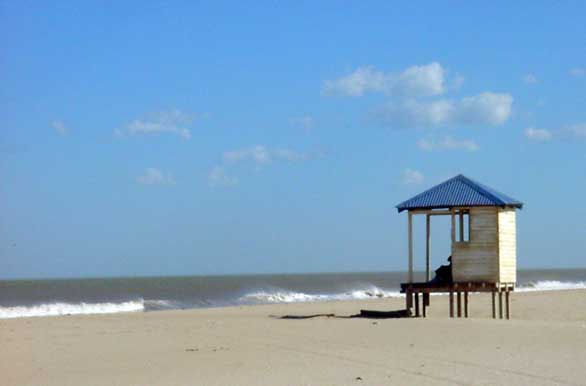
[0,299,144,319]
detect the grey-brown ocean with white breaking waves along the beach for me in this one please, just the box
[0,269,586,318]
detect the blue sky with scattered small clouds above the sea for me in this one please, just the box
[0,1,586,278]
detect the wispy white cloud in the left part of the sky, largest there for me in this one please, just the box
[114,109,195,140]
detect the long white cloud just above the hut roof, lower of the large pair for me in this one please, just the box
[377,92,513,128]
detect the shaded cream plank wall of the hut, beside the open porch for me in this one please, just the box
[452,207,500,283]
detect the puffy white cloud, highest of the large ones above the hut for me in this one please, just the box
[322,62,446,97]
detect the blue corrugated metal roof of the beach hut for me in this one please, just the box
[397,174,523,212]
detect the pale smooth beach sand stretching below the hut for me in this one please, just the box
[0,290,586,385]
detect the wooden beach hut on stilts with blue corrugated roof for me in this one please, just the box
[397,175,523,318]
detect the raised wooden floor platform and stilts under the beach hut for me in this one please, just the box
[401,281,515,319]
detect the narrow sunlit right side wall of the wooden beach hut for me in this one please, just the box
[498,209,517,283]
